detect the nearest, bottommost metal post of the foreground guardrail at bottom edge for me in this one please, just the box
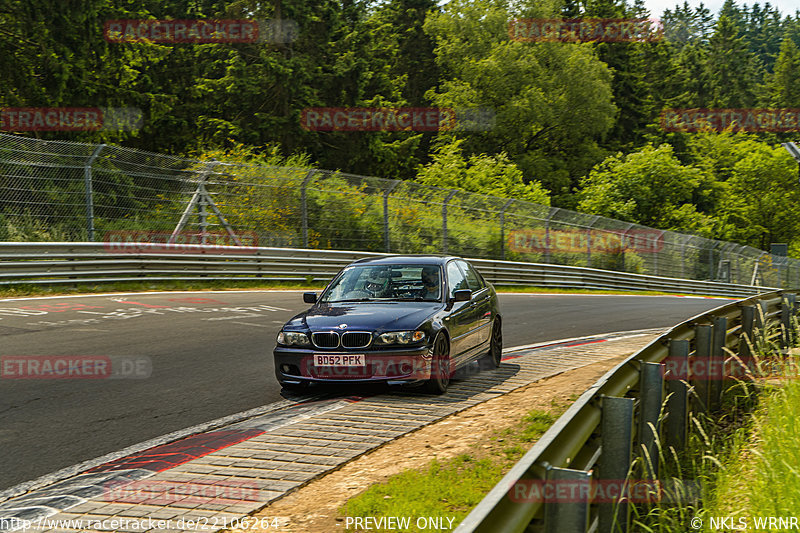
[544,467,592,533]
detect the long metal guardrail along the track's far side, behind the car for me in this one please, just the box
[0,242,773,297]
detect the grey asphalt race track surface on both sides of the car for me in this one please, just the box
[0,291,726,490]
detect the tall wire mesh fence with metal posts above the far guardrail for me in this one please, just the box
[0,134,800,287]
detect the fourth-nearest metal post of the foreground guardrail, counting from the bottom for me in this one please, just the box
[664,339,689,450]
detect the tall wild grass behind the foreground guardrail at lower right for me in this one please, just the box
[633,322,800,533]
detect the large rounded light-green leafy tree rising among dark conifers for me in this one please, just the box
[425,0,616,202]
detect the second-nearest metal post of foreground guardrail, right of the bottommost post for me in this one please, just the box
[597,396,636,533]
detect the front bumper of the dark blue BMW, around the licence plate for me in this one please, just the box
[273,345,438,383]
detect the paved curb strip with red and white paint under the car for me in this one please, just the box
[0,330,662,533]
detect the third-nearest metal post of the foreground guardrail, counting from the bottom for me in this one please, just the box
[639,363,664,479]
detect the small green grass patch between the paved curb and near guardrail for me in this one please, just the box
[340,397,575,531]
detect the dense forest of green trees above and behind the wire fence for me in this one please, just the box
[0,0,800,257]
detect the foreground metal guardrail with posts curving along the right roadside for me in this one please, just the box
[455,291,797,533]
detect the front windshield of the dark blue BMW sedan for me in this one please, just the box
[320,264,442,303]
